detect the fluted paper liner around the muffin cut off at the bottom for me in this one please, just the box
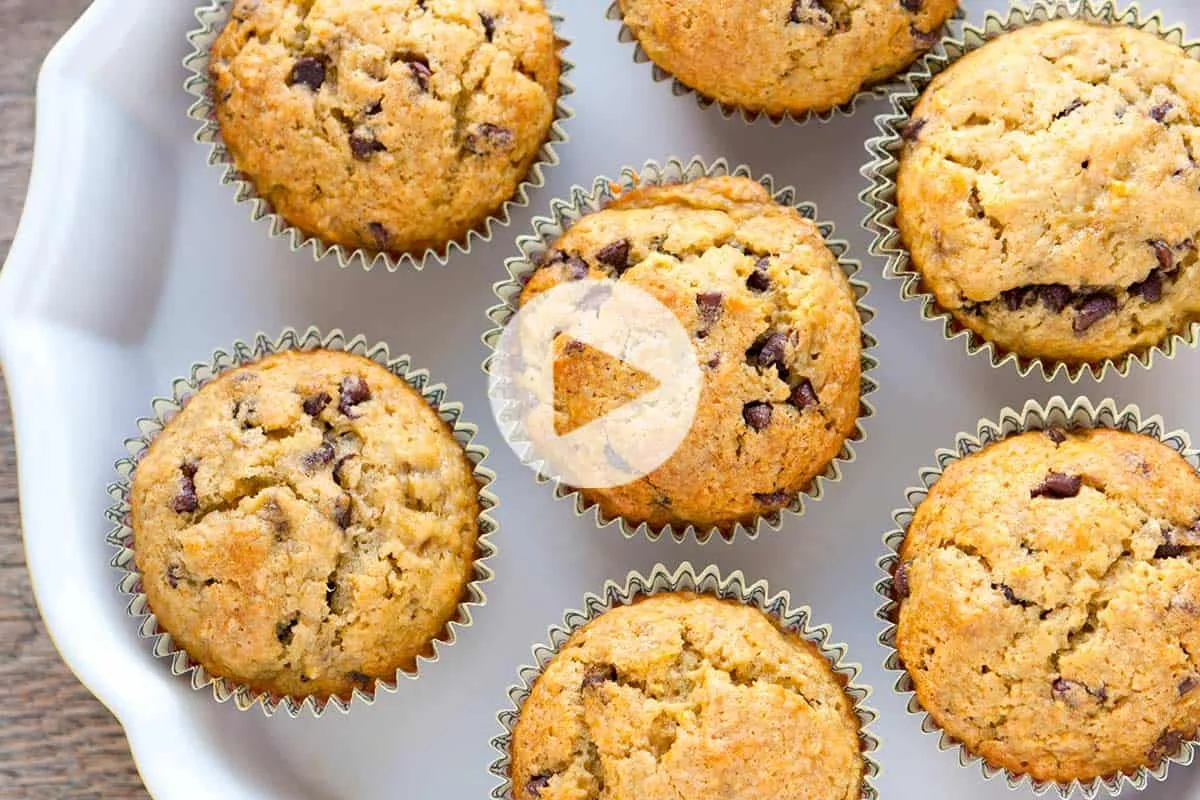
[491,561,880,800]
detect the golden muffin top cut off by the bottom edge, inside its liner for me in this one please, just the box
[511,593,864,800]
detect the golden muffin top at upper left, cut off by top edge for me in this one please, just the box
[210,0,559,255]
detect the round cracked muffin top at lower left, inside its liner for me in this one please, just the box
[130,350,480,698]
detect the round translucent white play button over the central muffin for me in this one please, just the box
[488,279,703,489]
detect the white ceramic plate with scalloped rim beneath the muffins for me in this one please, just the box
[7,0,1200,800]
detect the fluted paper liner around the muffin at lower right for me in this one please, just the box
[875,396,1200,800]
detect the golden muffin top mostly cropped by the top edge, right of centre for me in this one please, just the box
[620,0,958,116]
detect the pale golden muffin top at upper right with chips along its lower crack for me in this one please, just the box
[896,19,1200,363]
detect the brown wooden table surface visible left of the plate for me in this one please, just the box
[0,0,150,800]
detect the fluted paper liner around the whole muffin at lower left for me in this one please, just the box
[106,327,498,717]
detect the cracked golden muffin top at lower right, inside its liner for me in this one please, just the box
[893,429,1200,783]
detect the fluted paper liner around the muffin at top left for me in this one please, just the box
[184,0,575,272]
